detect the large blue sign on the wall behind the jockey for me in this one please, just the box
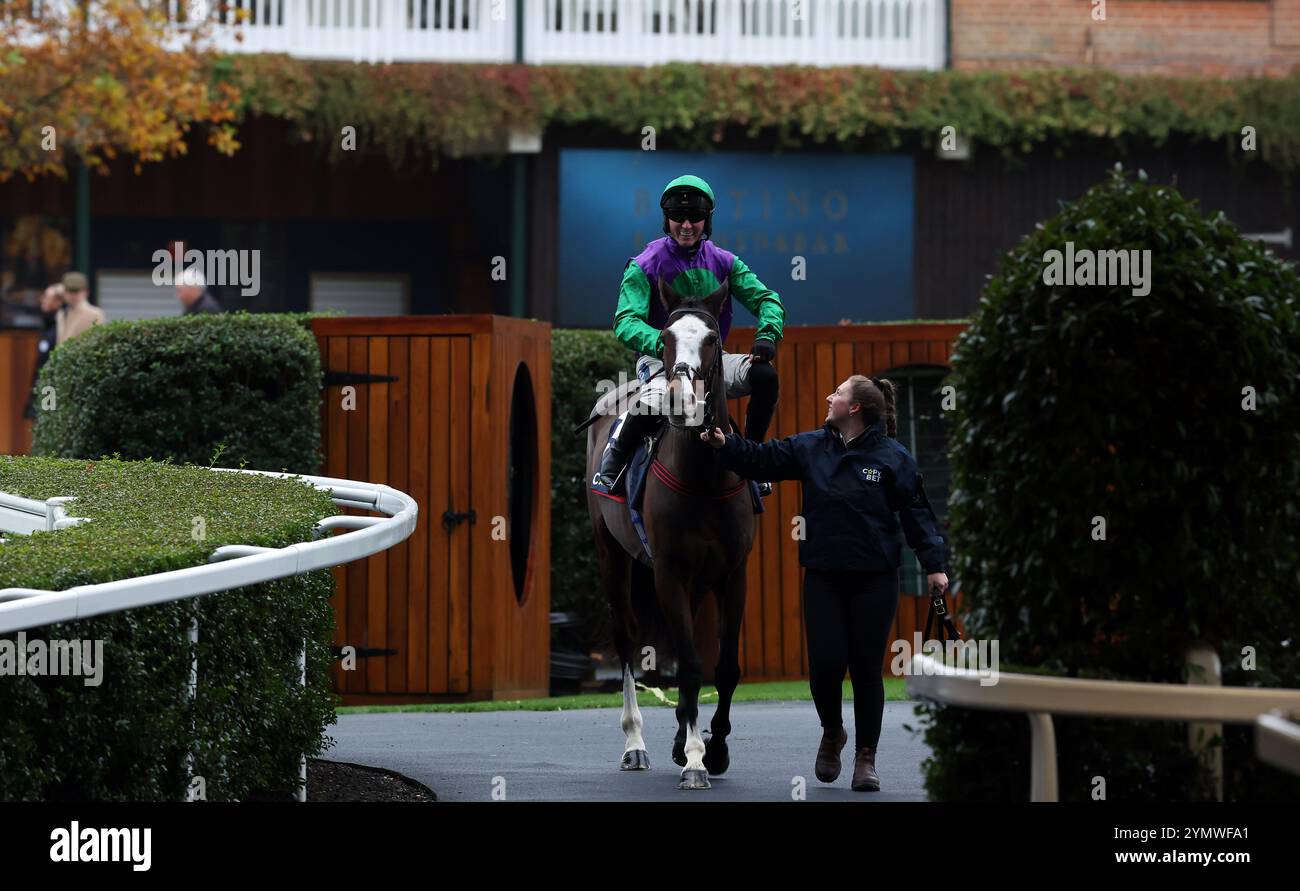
[555,148,915,328]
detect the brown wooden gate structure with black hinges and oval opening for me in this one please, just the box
[312,316,551,705]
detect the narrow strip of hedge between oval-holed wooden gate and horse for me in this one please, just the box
[551,328,634,648]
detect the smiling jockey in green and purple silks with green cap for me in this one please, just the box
[599,174,785,496]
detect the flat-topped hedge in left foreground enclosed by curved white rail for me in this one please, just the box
[0,455,337,800]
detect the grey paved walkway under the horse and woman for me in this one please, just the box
[321,702,930,801]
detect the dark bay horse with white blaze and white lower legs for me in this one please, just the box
[586,280,757,790]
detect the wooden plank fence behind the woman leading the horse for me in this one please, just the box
[697,323,965,680]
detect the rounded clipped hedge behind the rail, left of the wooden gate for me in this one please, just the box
[33,312,321,473]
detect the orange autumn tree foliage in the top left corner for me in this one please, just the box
[0,0,239,181]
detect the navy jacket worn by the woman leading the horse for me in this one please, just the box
[720,421,944,574]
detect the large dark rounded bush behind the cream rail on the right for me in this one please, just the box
[922,169,1300,800]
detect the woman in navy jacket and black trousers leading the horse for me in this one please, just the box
[699,375,948,792]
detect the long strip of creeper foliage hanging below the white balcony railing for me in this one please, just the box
[212,53,1300,170]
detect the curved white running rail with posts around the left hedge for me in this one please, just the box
[0,467,417,801]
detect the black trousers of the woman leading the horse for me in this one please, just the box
[803,570,898,751]
